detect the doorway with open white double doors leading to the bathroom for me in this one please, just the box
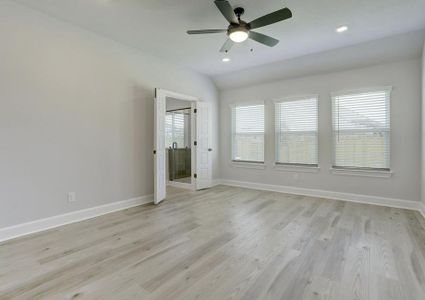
[153,89,213,204]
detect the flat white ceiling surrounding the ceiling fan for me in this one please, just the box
[11,0,425,75]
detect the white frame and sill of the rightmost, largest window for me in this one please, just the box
[330,86,393,178]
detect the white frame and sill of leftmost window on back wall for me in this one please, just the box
[229,101,267,165]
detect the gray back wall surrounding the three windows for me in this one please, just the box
[220,59,422,201]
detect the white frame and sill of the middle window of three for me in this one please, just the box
[273,94,320,173]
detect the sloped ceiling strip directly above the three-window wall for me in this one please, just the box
[212,29,425,90]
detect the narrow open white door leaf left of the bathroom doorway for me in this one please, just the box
[154,89,167,204]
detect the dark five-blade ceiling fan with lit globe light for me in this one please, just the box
[187,0,292,52]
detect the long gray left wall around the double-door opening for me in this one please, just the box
[0,1,218,228]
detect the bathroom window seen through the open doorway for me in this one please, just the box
[165,111,185,148]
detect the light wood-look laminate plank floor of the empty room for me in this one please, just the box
[0,186,425,300]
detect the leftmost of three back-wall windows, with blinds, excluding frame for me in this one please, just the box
[232,104,264,162]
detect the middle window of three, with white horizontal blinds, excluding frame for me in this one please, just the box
[275,96,318,166]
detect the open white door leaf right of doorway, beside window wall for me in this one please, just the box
[195,102,213,190]
